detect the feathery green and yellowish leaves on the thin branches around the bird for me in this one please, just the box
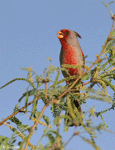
[1,35,115,149]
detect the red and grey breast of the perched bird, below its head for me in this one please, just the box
[60,46,84,77]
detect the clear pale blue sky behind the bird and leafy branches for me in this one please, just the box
[0,0,115,150]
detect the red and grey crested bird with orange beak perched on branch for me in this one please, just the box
[57,29,85,126]
